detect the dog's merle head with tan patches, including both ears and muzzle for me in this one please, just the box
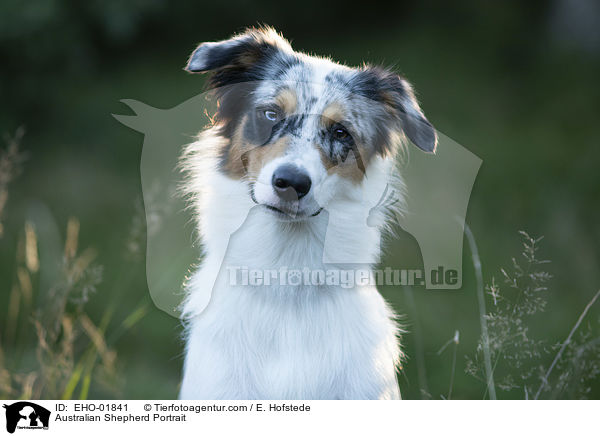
[186,29,437,220]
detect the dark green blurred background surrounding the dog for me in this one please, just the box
[0,0,600,399]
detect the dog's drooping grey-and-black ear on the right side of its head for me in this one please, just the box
[358,67,437,153]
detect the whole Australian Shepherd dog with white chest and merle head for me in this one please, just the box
[180,24,437,399]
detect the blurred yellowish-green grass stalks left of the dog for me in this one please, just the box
[0,129,149,400]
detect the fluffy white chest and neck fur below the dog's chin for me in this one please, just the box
[180,144,400,399]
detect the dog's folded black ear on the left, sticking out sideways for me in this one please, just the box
[185,27,292,87]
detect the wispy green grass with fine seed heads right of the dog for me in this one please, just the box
[466,230,600,399]
